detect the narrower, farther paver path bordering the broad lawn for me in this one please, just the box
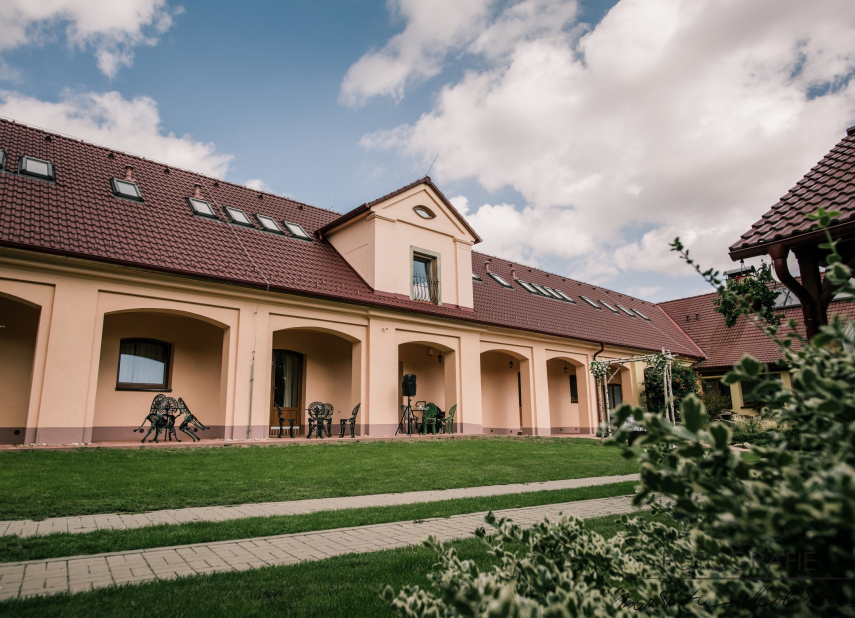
[0,474,638,537]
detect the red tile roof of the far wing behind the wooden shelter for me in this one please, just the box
[659,292,855,369]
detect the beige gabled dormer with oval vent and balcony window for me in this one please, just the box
[317,177,481,309]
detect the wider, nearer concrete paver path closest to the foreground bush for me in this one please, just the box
[0,490,632,600]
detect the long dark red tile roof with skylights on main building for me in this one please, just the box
[0,120,703,357]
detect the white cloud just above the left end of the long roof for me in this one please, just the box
[0,90,232,177]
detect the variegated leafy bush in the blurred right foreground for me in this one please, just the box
[384,211,855,618]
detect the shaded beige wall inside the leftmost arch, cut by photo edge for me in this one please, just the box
[0,296,39,444]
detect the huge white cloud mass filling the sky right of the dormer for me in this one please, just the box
[356,0,855,278]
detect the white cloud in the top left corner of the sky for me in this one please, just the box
[0,0,184,78]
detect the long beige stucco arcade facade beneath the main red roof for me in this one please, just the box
[0,249,668,443]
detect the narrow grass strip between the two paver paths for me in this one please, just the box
[0,481,636,564]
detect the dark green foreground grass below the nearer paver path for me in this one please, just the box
[0,513,666,618]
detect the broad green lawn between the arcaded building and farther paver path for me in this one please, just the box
[0,437,638,519]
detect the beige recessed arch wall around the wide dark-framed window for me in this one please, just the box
[92,312,228,442]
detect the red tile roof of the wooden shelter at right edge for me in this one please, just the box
[730,127,855,259]
